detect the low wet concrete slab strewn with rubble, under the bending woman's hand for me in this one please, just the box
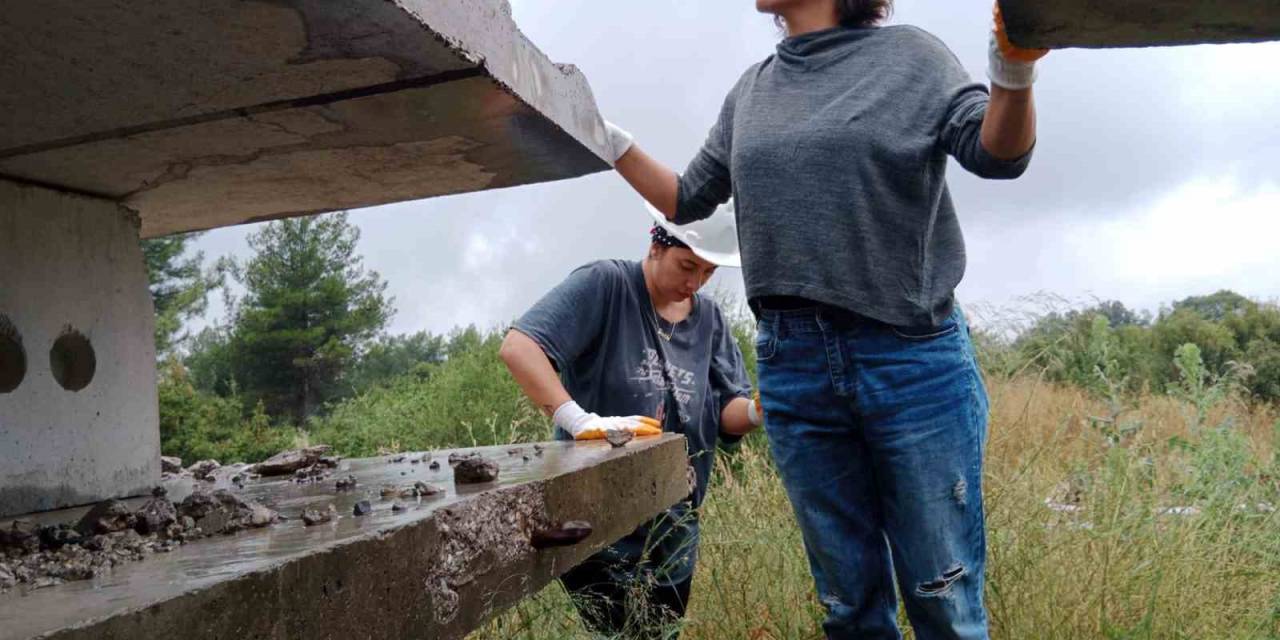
[0,434,689,640]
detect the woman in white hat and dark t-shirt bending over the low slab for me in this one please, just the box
[500,210,760,637]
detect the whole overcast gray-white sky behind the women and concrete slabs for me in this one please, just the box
[189,0,1280,333]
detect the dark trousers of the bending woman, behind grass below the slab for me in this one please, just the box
[561,558,694,640]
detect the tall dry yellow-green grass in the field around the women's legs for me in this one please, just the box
[471,375,1280,640]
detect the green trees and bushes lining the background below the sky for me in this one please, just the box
[143,214,1280,462]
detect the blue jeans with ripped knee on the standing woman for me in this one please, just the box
[756,307,988,640]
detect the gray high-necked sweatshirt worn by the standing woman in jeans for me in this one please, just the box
[676,26,1030,326]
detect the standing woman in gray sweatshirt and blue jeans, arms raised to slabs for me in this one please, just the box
[593,0,1044,640]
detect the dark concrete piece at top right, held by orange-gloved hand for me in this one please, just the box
[1000,0,1280,49]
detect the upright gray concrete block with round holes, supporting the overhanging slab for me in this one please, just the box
[0,180,160,516]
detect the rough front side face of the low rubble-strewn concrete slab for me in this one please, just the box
[33,436,689,640]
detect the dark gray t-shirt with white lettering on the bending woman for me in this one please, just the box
[515,260,751,582]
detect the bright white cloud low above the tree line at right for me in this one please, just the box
[960,177,1280,320]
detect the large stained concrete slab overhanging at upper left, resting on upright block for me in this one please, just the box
[0,0,607,237]
